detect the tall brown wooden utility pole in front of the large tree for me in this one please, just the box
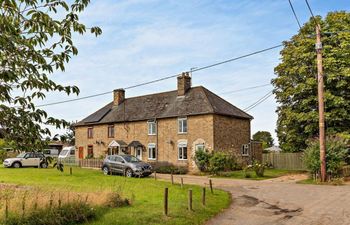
[316,24,327,182]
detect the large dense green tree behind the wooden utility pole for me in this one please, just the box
[272,11,350,152]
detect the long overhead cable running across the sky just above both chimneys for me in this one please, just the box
[36,44,283,107]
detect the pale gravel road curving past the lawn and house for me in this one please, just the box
[157,174,350,225]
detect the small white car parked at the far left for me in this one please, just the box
[3,152,48,168]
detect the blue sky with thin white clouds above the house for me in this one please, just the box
[37,0,350,144]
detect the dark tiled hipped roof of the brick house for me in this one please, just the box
[75,86,253,126]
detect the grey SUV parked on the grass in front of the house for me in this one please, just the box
[102,155,152,177]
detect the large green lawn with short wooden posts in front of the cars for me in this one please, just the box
[0,167,230,225]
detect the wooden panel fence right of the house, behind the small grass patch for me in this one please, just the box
[262,152,306,170]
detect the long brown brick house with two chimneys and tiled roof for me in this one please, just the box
[75,73,256,170]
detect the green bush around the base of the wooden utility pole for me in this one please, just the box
[303,136,347,176]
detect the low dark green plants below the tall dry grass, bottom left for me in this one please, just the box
[4,201,97,225]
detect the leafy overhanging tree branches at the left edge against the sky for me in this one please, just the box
[0,0,102,150]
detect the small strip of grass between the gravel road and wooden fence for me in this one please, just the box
[217,169,303,180]
